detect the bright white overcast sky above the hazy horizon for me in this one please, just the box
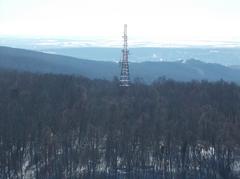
[0,0,240,42]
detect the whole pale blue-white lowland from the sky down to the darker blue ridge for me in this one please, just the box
[0,37,240,66]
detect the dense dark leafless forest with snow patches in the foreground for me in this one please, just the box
[0,71,240,179]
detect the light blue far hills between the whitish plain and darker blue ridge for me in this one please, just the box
[41,47,240,66]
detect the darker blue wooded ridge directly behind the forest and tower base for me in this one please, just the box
[0,47,240,83]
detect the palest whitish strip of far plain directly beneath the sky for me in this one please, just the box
[0,35,240,48]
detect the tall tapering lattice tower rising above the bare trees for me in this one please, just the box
[120,24,130,87]
